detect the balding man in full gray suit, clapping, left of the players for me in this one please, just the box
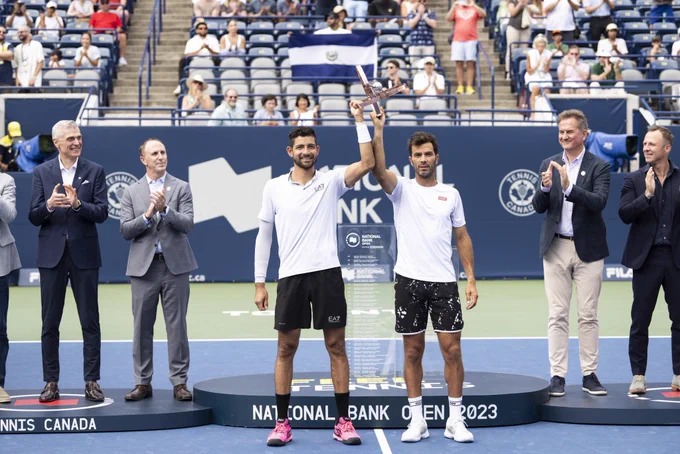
[120,139,198,401]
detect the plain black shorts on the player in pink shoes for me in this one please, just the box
[274,268,347,331]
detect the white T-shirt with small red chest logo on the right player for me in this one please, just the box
[387,177,465,282]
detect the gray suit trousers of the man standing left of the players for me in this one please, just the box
[130,259,189,386]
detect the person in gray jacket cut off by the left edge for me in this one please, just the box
[0,173,21,403]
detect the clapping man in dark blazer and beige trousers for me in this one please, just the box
[532,110,610,397]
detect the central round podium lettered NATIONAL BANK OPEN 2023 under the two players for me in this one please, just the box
[194,372,549,429]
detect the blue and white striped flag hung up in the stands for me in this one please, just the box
[288,32,378,81]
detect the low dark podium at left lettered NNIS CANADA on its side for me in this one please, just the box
[0,389,212,434]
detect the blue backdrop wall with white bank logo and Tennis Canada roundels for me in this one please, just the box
[11,127,627,282]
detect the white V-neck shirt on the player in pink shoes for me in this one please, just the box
[257,168,350,279]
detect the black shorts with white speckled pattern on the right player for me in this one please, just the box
[394,274,463,334]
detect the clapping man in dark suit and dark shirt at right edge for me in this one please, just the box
[619,126,680,394]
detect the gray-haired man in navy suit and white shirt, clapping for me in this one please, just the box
[28,120,108,402]
